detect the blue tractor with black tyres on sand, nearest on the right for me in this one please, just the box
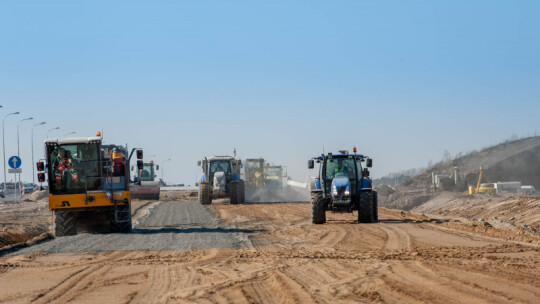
[308,147,378,224]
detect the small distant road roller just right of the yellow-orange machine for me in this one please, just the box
[130,161,160,200]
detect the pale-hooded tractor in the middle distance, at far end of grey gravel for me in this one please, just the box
[197,156,246,205]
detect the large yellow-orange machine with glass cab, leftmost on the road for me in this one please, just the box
[37,133,142,236]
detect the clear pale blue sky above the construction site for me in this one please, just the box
[0,1,540,184]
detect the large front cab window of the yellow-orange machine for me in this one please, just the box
[47,143,101,194]
